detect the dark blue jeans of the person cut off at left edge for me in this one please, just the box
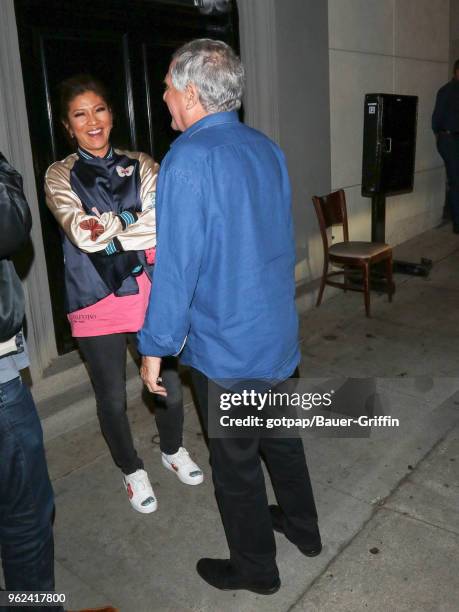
[0,378,62,611]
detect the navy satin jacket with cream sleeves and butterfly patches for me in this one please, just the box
[45,148,159,312]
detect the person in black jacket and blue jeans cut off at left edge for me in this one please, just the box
[0,153,115,612]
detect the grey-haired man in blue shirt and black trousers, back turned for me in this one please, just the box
[139,39,321,594]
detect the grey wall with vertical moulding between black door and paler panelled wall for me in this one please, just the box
[237,0,331,283]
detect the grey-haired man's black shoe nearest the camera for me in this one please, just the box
[196,559,280,595]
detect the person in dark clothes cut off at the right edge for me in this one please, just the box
[432,60,459,234]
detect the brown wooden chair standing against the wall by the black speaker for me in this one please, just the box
[312,189,394,317]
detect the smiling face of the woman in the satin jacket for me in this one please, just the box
[64,91,113,157]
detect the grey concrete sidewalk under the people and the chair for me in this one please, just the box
[40,227,459,612]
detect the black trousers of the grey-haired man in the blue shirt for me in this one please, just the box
[191,368,319,580]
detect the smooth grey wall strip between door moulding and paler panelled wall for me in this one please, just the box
[275,0,331,283]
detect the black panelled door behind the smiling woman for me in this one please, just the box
[15,0,238,354]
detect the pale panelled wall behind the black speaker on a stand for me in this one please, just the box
[328,0,450,256]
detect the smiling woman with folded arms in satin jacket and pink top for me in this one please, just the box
[45,75,203,513]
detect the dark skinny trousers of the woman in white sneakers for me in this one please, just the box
[77,334,183,474]
